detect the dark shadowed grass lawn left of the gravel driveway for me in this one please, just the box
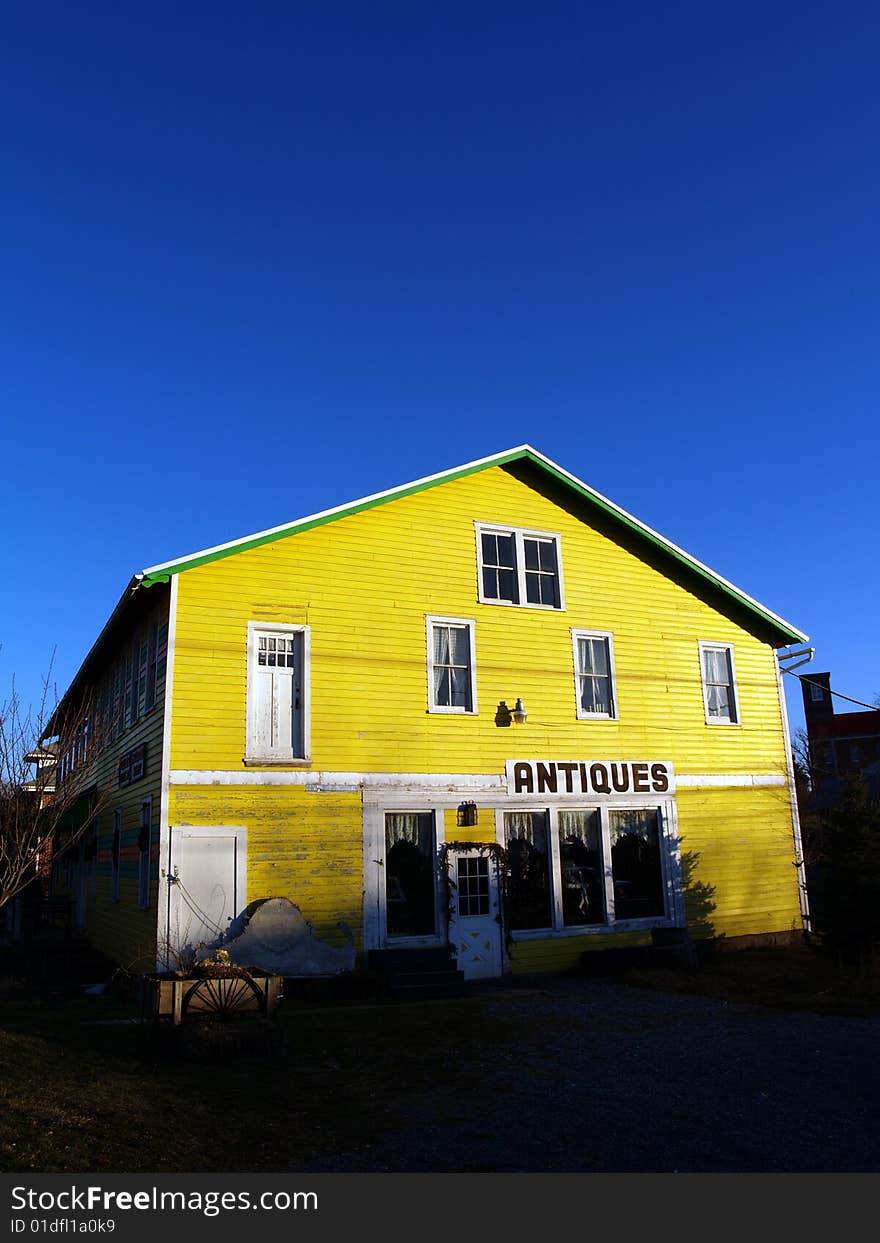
[0,989,516,1172]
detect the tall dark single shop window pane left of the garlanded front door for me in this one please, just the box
[385,812,436,936]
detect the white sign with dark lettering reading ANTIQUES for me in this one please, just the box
[506,759,675,796]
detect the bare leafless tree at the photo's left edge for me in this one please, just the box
[0,663,108,910]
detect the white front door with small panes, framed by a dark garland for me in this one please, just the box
[447,848,503,979]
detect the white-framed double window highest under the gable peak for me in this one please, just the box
[476,522,566,609]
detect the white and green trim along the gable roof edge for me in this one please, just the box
[137,445,808,645]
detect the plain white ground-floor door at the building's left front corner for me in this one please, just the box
[165,825,246,967]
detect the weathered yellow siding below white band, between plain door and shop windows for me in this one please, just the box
[168,786,363,950]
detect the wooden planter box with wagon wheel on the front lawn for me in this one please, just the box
[140,971,285,1027]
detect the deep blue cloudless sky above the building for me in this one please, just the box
[0,0,880,725]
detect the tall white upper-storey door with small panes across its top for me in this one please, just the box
[245,622,309,763]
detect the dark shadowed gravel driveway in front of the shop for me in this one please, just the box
[291,977,880,1173]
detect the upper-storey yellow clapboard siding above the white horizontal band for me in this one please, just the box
[172,467,784,773]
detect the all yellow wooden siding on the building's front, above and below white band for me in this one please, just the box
[161,467,798,954]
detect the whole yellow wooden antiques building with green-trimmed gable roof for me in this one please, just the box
[49,446,805,977]
